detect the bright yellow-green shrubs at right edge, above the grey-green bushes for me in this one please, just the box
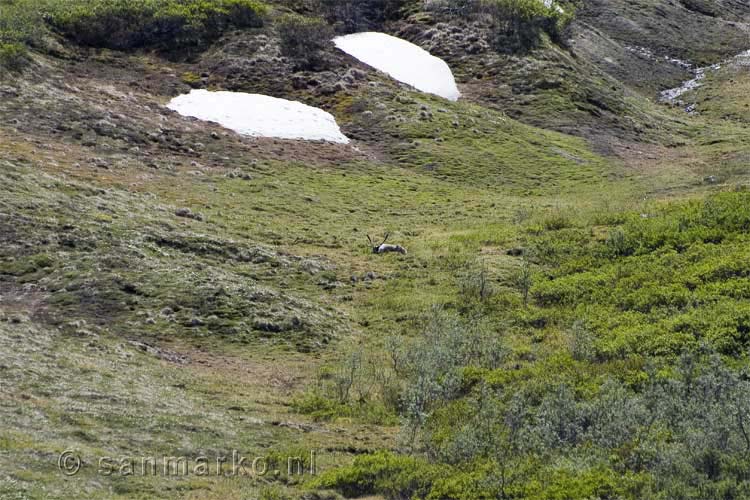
[530,193,750,360]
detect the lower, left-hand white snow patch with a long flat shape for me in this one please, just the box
[167,90,349,144]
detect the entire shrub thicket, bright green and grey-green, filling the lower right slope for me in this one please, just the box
[320,192,750,500]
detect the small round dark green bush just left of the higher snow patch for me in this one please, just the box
[277,14,333,70]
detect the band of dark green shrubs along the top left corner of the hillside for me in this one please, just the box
[0,0,266,60]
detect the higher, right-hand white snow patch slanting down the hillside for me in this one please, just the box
[333,32,461,101]
